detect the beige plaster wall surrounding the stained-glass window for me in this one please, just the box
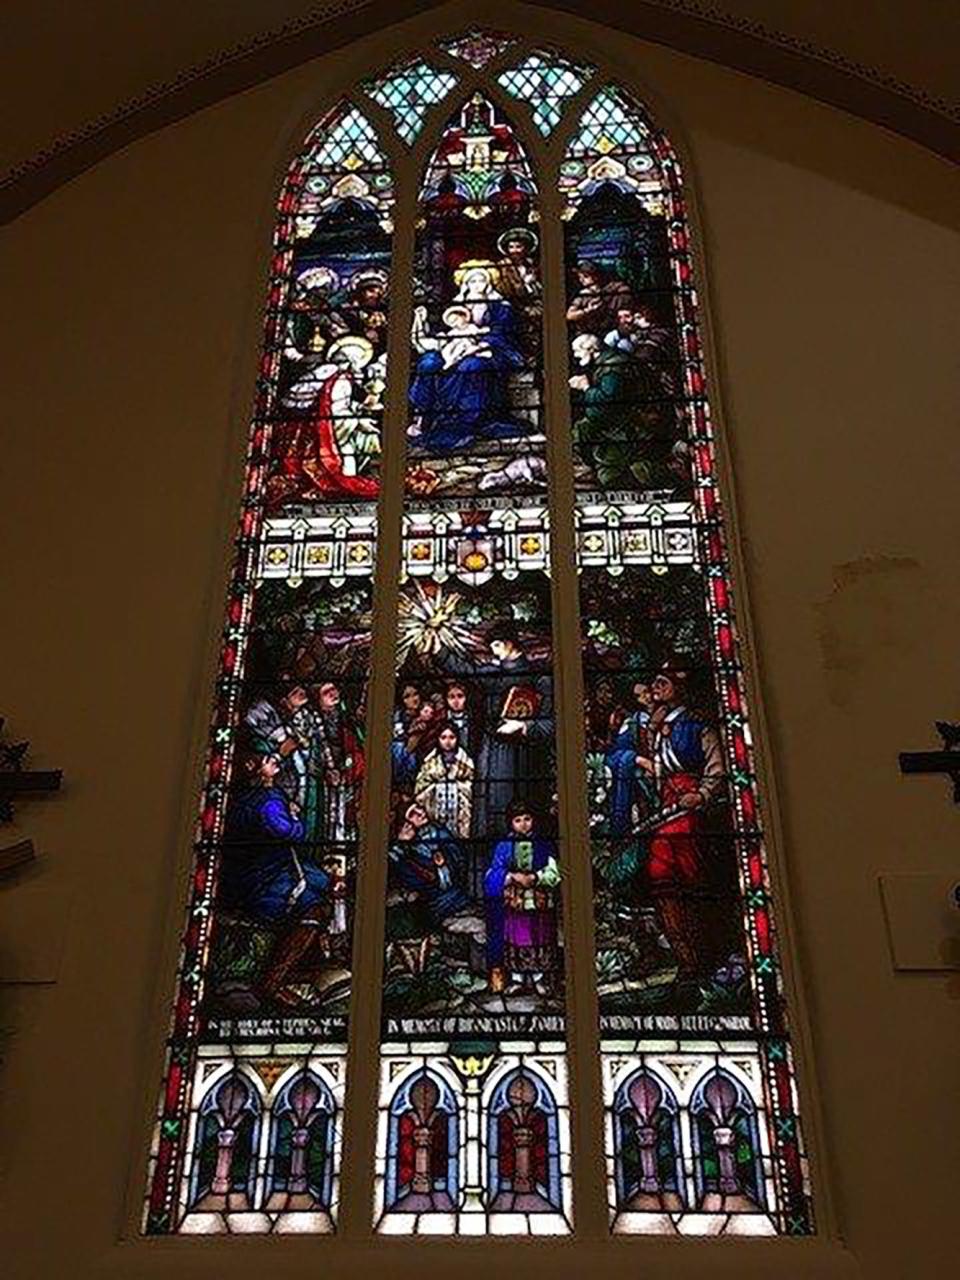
[0,5,960,1280]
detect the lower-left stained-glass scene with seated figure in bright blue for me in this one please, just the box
[207,579,371,1025]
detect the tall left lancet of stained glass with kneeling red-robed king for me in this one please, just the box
[145,104,393,1234]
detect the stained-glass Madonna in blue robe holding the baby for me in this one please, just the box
[408,265,527,454]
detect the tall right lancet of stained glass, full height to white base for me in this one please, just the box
[561,88,813,1235]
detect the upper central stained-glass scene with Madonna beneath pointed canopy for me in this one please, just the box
[407,93,545,498]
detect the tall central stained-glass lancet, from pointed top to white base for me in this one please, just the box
[376,95,571,1234]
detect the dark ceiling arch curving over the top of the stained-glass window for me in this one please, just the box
[0,0,960,220]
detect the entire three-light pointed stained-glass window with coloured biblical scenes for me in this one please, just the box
[143,29,814,1238]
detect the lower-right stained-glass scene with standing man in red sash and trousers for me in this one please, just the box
[581,567,750,1015]
